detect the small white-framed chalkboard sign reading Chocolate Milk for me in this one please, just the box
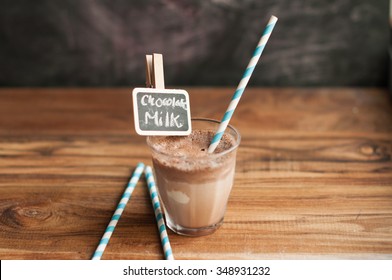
[132,88,192,135]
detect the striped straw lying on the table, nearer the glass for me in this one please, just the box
[144,165,174,260]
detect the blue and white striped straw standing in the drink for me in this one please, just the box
[208,16,278,153]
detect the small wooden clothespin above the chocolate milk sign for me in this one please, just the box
[146,53,165,89]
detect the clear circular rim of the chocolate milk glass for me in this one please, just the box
[146,117,241,160]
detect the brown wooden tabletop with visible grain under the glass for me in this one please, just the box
[0,88,392,259]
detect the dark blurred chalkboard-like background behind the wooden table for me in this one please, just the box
[0,0,389,87]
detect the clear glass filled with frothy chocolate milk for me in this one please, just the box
[147,119,240,236]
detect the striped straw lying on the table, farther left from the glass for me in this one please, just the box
[92,162,144,260]
